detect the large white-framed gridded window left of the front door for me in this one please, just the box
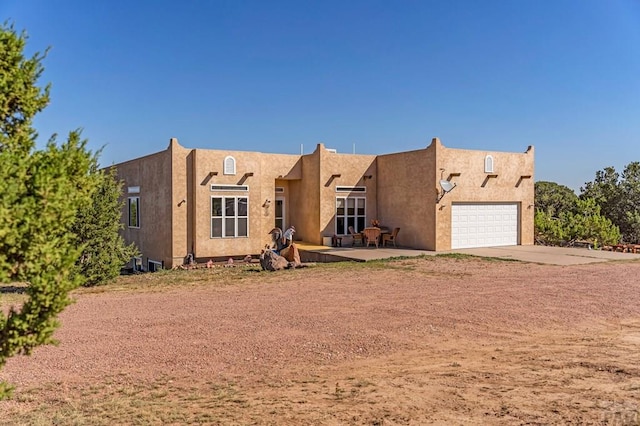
[211,197,249,238]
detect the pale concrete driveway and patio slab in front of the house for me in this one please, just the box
[296,242,640,265]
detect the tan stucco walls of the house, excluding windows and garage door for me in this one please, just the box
[115,138,534,267]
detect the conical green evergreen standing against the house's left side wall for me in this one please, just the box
[73,168,138,286]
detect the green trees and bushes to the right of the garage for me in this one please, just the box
[535,161,640,248]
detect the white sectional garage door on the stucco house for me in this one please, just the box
[451,203,518,249]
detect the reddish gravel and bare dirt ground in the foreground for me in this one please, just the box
[0,257,640,425]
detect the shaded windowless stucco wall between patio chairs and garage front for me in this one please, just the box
[377,147,436,250]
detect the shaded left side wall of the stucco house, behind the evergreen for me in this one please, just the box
[115,151,172,268]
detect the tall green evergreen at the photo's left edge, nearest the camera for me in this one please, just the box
[0,24,96,398]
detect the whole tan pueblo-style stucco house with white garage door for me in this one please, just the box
[113,138,534,270]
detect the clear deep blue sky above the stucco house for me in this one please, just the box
[5,0,640,190]
